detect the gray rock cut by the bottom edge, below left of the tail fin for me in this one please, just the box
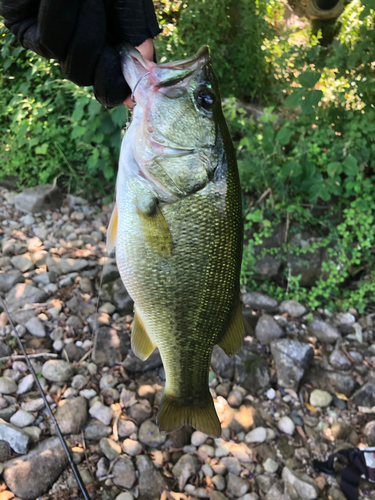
[136,455,167,500]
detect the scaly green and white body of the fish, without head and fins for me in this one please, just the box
[116,139,242,406]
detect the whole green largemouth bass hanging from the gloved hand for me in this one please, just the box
[107,45,244,437]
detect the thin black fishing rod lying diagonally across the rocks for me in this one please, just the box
[0,297,91,500]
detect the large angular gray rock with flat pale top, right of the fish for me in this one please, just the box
[271,339,314,390]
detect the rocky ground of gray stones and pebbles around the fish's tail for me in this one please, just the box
[0,188,375,500]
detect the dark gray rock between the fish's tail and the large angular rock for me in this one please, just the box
[234,346,270,395]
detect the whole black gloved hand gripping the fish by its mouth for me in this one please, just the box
[0,0,160,107]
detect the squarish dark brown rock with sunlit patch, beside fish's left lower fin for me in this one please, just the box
[94,326,130,366]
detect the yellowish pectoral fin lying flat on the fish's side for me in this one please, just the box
[137,197,172,257]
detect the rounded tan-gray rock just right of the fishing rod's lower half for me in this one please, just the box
[55,396,87,434]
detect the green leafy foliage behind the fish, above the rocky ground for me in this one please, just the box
[0,0,375,311]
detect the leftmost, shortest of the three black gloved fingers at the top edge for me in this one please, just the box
[38,0,83,59]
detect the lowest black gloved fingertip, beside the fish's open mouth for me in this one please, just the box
[94,45,130,108]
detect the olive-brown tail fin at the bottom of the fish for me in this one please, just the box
[158,394,221,437]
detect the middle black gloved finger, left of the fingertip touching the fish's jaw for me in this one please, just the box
[61,0,106,86]
